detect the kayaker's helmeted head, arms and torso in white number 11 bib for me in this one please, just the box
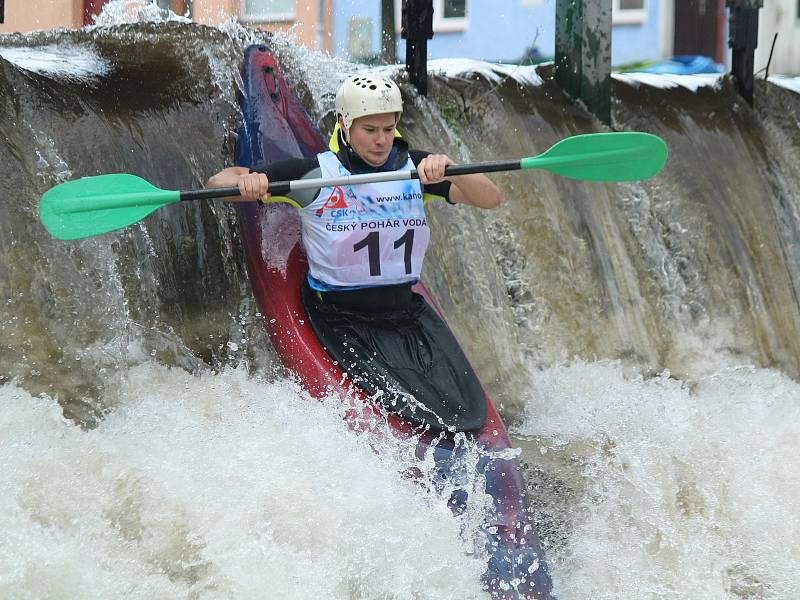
[208,75,500,300]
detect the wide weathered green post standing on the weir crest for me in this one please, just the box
[555,0,611,125]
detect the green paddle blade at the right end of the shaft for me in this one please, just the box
[520,131,667,181]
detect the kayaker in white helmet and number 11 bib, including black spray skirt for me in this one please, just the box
[208,75,500,431]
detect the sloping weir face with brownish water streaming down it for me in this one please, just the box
[0,23,800,412]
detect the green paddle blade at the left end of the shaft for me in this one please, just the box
[39,175,180,240]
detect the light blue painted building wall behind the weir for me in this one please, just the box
[333,0,660,64]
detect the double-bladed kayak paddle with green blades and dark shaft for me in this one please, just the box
[39,132,667,240]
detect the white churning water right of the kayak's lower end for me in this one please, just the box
[512,362,800,600]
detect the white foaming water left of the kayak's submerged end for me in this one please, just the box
[0,363,485,599]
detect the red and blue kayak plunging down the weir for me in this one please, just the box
[236,46,551,598]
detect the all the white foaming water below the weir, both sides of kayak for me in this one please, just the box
[0,362,800,600]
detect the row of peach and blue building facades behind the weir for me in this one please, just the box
[0,0,800,74]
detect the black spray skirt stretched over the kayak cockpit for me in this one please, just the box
[302,285,486,431]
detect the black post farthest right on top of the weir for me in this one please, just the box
[725,0,764,106]
